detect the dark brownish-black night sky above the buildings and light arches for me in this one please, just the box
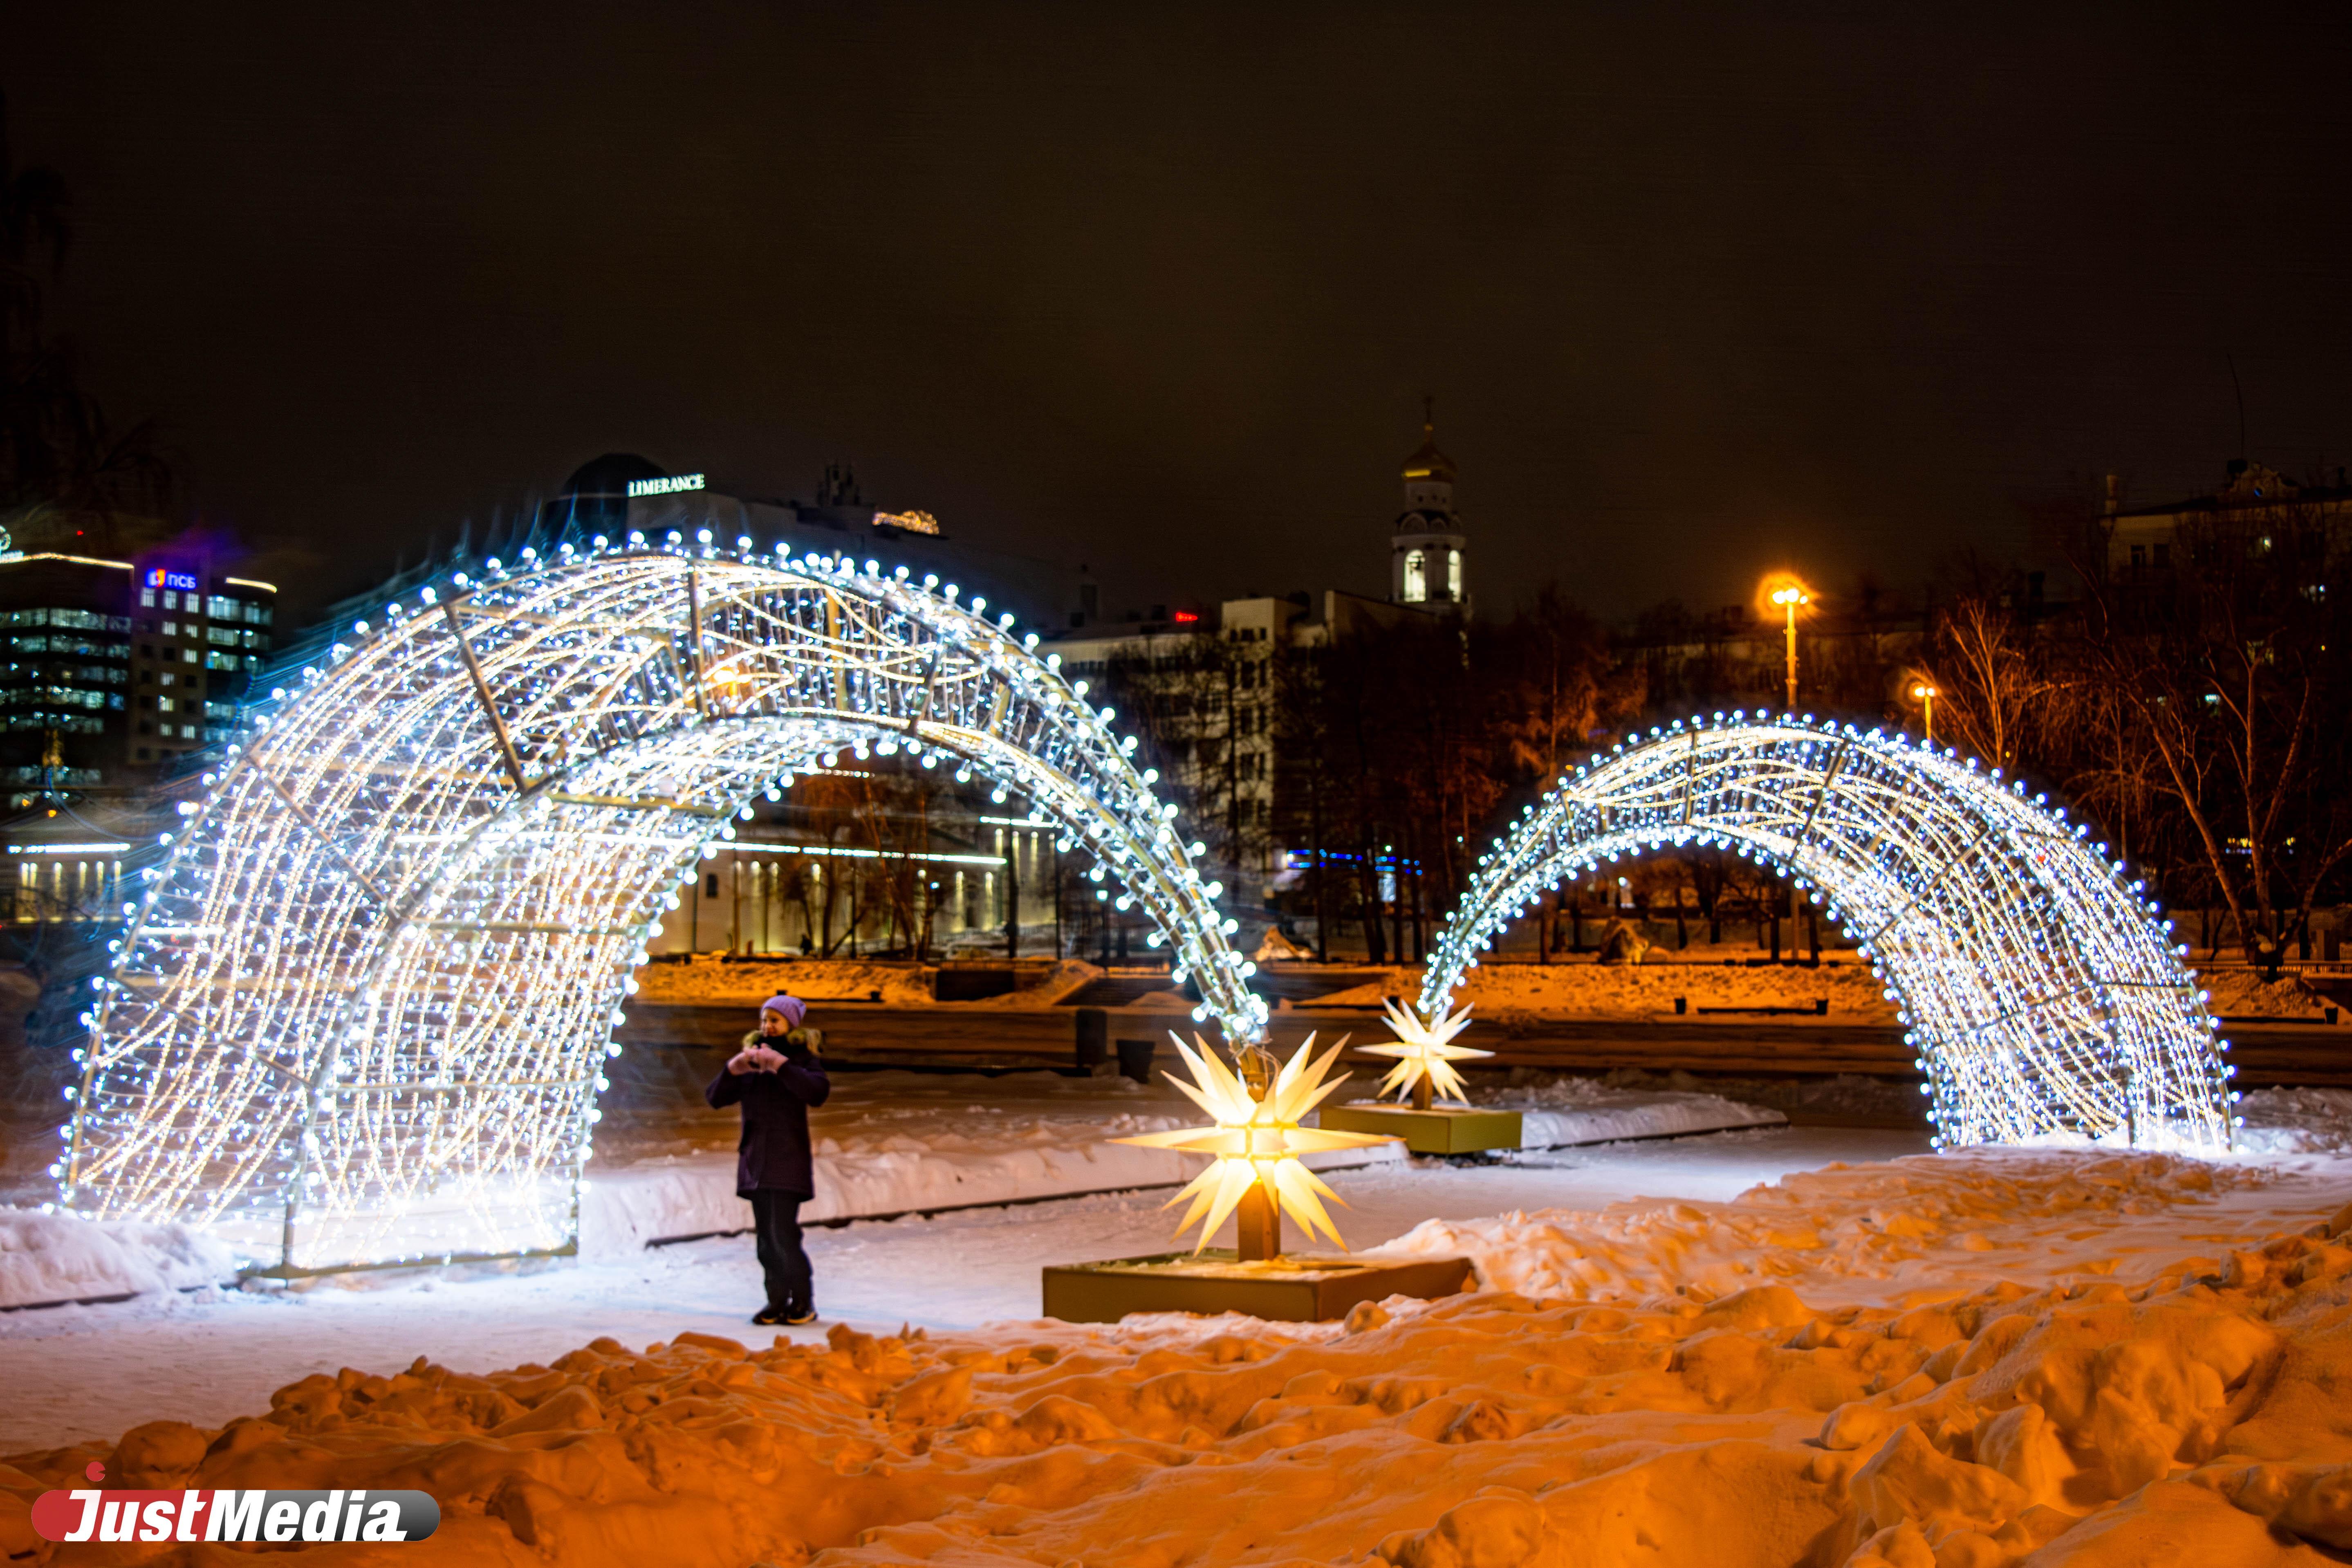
[13,2,2352,616]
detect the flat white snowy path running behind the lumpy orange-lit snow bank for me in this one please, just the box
[0,1128,1926,1453]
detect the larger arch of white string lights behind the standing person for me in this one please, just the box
[59,531,1265,1272]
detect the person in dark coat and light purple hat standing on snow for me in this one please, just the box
[703,994,833,1328]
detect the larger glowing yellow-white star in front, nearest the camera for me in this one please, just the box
[1112,1034,1395,1253]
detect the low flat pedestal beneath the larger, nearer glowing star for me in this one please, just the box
[1044,1246,1470,1323]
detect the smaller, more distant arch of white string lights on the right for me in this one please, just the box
[1418,715,2237,1150]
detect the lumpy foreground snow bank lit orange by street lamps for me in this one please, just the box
[0,1154,2352,1568]
